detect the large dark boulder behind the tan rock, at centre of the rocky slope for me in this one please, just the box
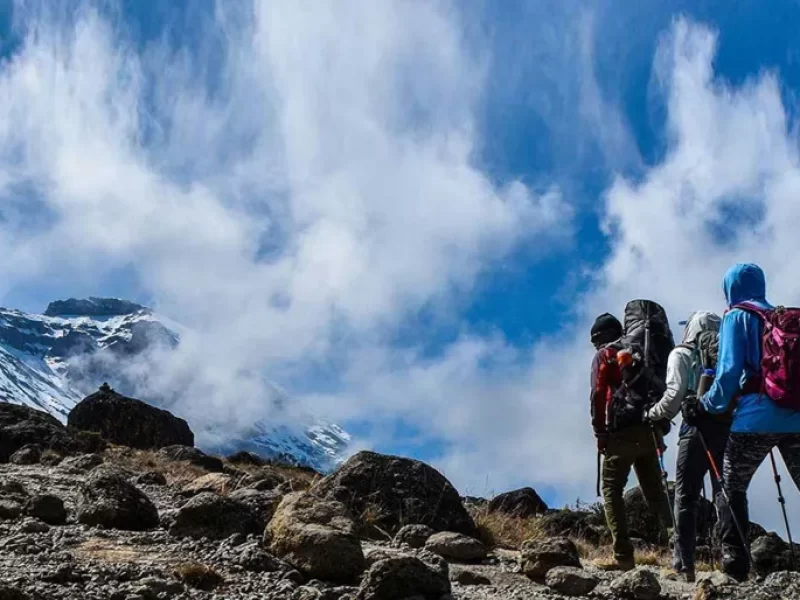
[311,451,476,535]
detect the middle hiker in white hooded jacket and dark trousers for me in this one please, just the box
[647,311,731,582]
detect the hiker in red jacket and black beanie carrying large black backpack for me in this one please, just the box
[591,300,674,571]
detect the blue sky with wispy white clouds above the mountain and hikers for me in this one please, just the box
[0,0,800,528]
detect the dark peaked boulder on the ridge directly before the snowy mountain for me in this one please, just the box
[67,384,194,450]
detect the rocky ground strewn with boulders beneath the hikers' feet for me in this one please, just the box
[0,398,800,600]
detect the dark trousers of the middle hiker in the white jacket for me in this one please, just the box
[674,417,730,571]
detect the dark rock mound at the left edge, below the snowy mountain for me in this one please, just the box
[0,402,81,463]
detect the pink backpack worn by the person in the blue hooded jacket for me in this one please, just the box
[731,302,800,410]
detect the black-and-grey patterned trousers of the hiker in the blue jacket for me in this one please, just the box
[722,433,800,577]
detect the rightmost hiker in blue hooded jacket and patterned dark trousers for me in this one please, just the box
[697,264,800,581]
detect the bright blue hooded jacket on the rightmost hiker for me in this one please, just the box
[701,263,800,433]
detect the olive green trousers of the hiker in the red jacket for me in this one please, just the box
[603,424,672,560]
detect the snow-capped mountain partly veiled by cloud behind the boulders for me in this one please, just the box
[0,298,350,471]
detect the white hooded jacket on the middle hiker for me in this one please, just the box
[647,311,722,421]
